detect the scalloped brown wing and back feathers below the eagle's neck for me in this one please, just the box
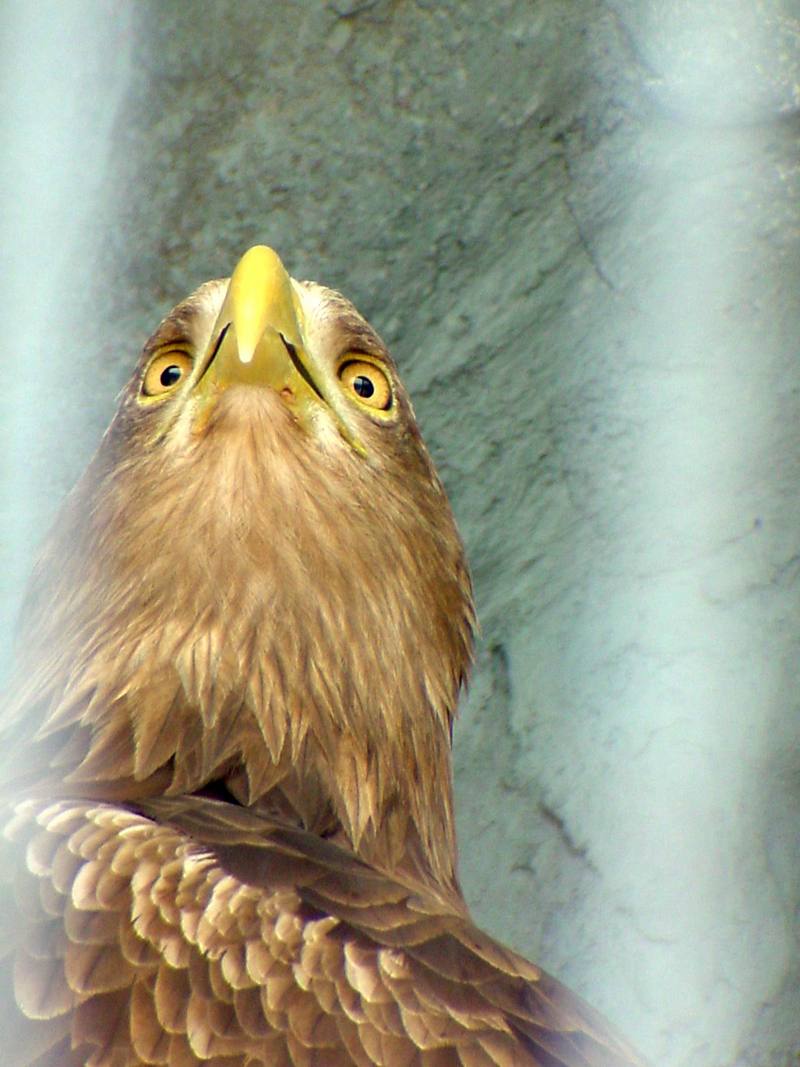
[3,797,641,1067]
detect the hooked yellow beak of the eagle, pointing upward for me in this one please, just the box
[194,244,364,453]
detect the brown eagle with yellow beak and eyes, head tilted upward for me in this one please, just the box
[0,246,641,1067]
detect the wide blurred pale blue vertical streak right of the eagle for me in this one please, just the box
[546,3,797,1067]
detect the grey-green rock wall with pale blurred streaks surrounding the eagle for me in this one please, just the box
[0,0,800,1067]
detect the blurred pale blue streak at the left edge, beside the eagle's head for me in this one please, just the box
[0,0,129,675]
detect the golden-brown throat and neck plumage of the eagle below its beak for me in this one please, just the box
[3,392,473,885]
